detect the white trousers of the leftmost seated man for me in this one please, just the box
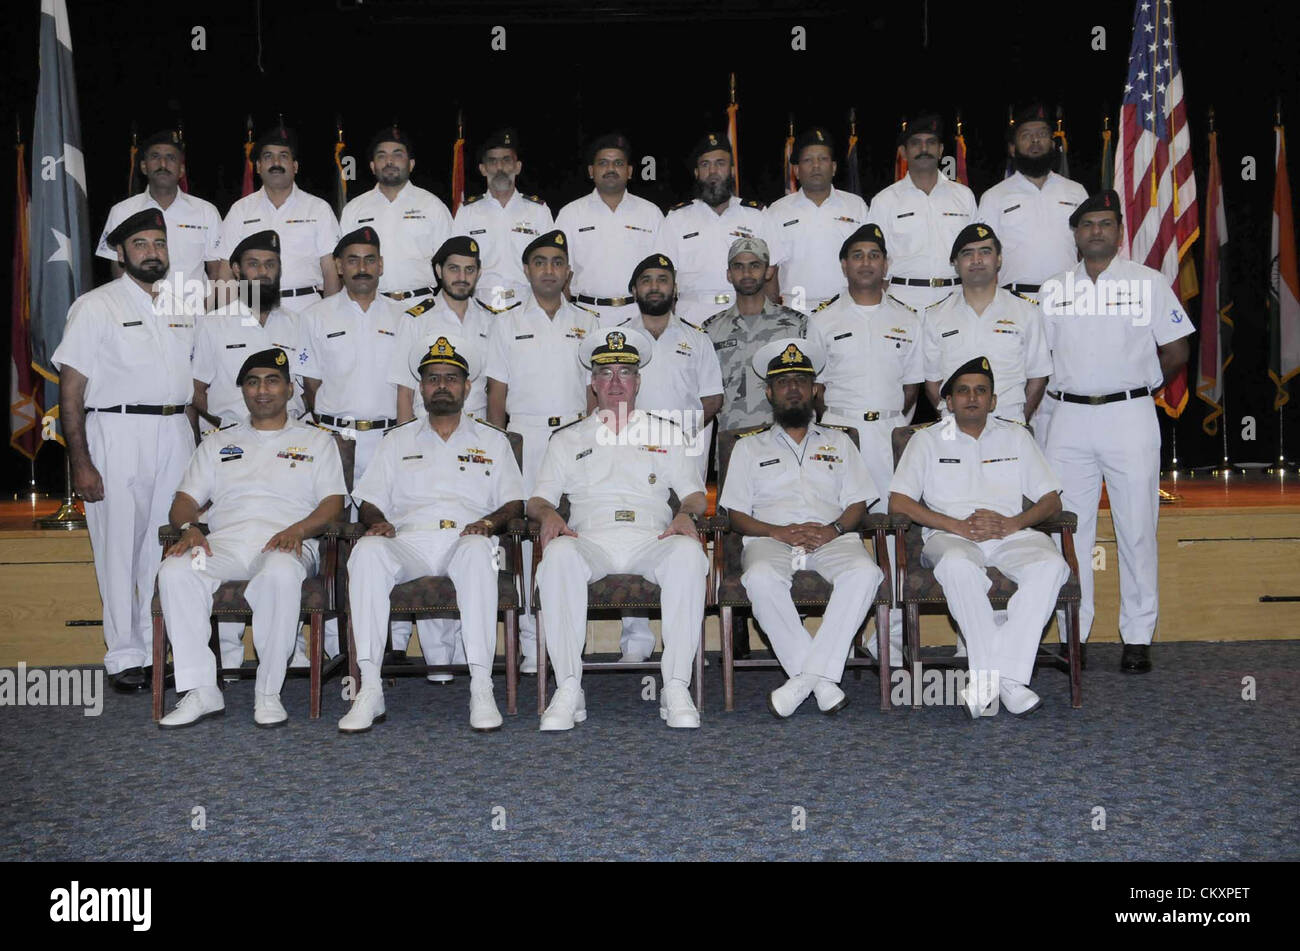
[159,526,319,694]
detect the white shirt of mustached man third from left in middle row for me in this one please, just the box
[298,288,410,420]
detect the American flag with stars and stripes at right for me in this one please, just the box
[1115,0,1200,416]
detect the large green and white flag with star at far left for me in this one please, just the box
[30,0,91,442]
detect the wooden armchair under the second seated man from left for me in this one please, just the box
[338,433,524,715]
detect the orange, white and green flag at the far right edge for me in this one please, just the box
[1269,122,1300,409]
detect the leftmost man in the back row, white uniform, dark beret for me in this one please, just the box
[95,130,224,289]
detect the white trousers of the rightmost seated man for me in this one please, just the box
[920,529,1070,683]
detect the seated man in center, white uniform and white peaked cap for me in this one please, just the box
[528,327,709,731]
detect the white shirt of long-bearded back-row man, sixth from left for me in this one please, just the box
[655,195,785,323]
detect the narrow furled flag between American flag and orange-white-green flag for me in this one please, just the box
[1196,118,1232,435]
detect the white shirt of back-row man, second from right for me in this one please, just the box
[871,174,976,279]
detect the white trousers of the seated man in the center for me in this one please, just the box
[537,529,709,686]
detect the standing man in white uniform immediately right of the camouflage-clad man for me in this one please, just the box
[807,223,924,666]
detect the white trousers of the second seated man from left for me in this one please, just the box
[347,529,497,673]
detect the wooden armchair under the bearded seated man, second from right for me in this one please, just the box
[709,429,892,712]
